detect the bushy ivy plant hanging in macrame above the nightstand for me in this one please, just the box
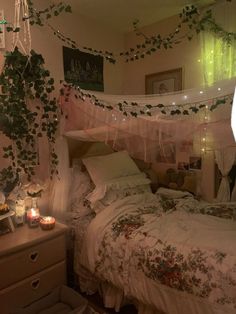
[0,48,58,193]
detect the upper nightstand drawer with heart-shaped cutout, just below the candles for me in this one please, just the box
[0,235,65,289]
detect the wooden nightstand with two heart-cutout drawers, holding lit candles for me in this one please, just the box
[0,223,67,314]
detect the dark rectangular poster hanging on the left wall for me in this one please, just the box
[63,47,104,92]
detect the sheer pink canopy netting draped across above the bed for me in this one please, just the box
[60,78,236,162]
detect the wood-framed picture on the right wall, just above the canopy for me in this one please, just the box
[145,68,182,94]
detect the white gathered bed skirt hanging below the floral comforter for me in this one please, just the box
[76,265,228,314]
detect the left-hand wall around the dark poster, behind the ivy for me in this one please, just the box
[0,0,124,94]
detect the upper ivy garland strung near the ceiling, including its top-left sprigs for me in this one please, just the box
[0,0,236,64]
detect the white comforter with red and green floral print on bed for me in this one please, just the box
[81,193,236,313]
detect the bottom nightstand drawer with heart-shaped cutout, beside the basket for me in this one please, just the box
[0,261,66,314]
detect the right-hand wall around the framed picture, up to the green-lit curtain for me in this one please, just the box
[124,16,202,95]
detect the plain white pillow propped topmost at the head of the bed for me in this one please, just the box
[82,151,141,186]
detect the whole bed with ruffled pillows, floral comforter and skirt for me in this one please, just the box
[66,146,236,314]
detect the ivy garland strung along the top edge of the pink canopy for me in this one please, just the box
[60,83,233,118]
